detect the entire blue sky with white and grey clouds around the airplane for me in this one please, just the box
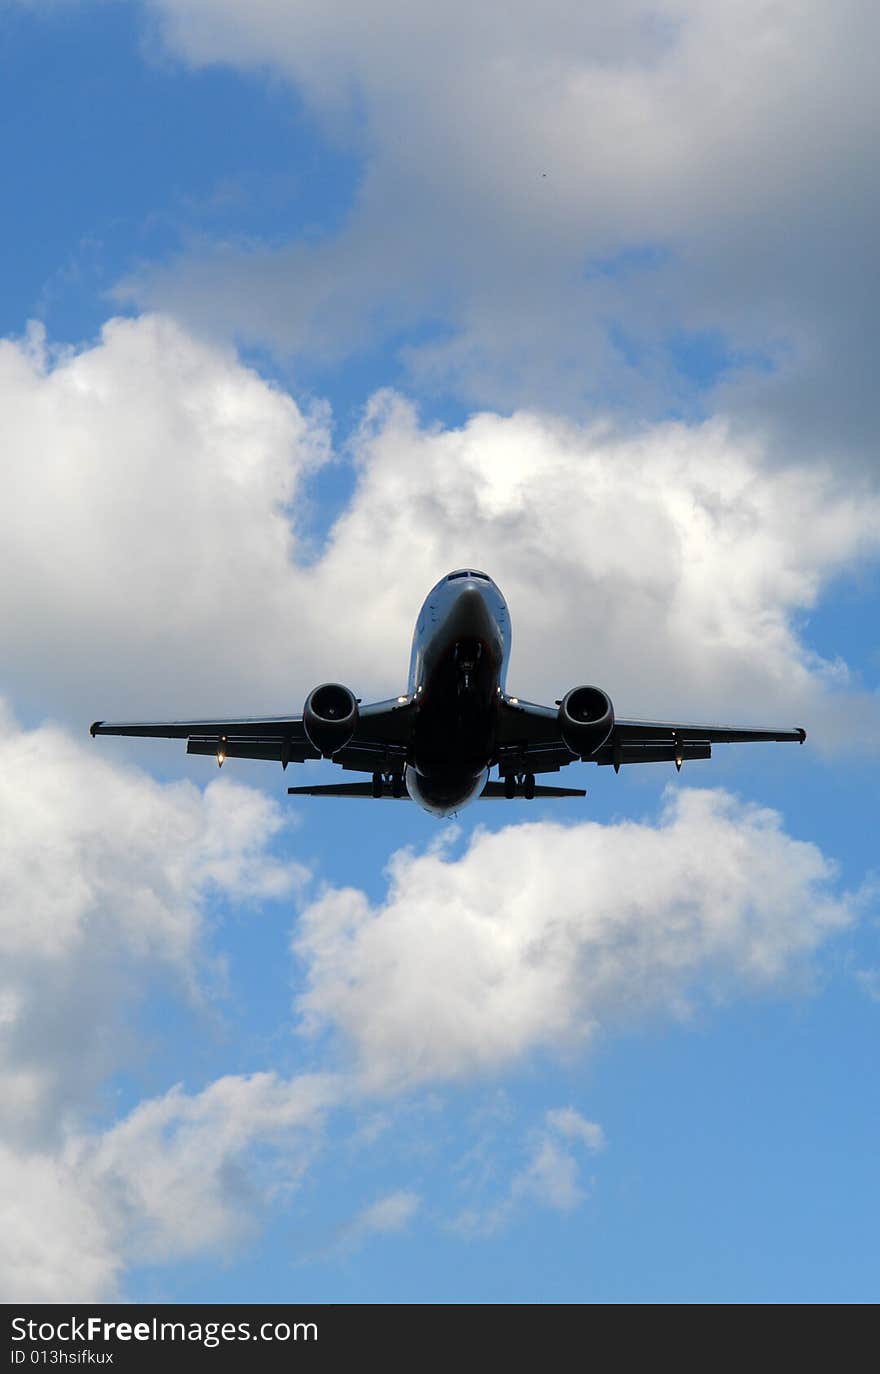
[0,0,880,1303]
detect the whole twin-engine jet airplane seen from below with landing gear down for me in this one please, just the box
[91,567,807,816]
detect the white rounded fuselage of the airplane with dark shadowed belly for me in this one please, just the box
[406,569,510,816]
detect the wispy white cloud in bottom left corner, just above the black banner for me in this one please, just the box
[0,1073,337,1303]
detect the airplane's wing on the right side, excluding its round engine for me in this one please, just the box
[498,698,807,774]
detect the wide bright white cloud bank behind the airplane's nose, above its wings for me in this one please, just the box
[0,317,880,747]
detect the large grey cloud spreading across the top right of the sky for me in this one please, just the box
[131,0,880,456]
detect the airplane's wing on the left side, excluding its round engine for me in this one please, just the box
[89,697,413,772]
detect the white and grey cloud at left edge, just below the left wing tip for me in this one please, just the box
[0,714,303,1142]
